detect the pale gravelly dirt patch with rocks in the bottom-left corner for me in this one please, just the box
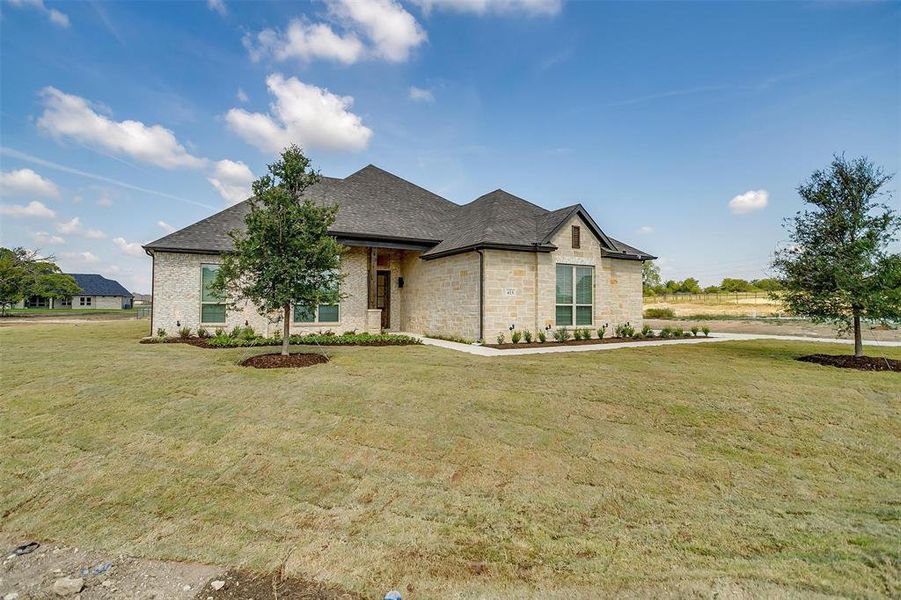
[0,537,222,600]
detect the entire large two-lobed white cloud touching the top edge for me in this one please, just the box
[243,0,427,64]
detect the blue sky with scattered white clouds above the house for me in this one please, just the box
[0,0,901,292]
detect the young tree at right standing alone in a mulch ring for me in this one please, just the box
[773,156,901,356]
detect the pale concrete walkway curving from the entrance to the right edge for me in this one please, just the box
[414,333,901,356]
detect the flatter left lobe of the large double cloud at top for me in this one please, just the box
[243,19,365,64]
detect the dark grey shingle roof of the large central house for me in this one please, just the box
[144,165,654,260]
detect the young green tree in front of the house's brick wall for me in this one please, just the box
[212,145,344,355]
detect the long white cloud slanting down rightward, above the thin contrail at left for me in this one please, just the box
[37,87,206,169]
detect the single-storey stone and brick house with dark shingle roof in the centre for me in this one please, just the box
[144,165,655,340]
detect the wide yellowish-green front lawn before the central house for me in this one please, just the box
[0,321,901,598]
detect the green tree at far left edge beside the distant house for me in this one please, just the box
[0,248,81,314]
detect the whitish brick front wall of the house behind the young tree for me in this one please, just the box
[153,248,367,335]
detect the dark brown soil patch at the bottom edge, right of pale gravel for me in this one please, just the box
[197,571,365,600]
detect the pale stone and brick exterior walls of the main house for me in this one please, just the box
[153,216,642,340]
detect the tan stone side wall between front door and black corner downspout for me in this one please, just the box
[401,252,479,340]
